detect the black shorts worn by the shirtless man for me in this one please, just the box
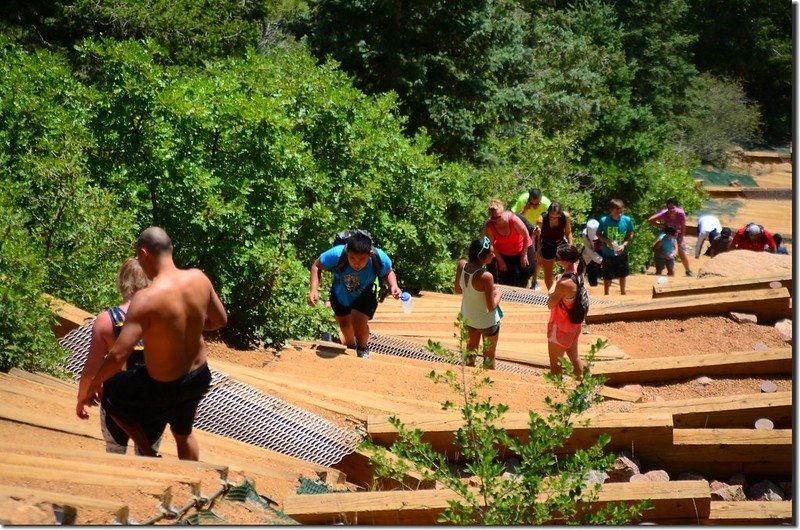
[102,363,211,435]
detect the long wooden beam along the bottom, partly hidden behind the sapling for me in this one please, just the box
[281,480,711,525]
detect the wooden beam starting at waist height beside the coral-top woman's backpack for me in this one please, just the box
[586,288,792,324]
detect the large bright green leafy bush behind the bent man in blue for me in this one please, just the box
[72,41,489,344]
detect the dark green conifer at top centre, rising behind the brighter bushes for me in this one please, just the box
[294,0,528,160]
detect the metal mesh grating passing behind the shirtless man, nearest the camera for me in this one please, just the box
[59,320,363,466]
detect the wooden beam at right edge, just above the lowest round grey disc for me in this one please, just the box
[636,392,792,429]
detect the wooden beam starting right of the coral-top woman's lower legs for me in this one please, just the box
[592,347,793,385]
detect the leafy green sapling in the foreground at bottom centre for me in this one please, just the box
[364,323,650,525]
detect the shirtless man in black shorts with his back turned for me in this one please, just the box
[77,226,228,460]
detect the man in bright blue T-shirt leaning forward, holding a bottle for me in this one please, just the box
[308,230,400,359]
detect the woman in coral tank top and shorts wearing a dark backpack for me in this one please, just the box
[547,244,588,379]
